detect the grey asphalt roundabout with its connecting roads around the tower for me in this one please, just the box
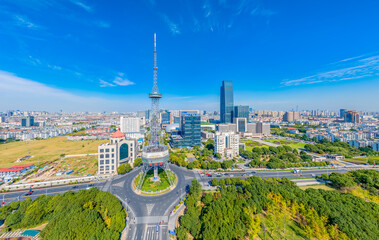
[0,164,378,240]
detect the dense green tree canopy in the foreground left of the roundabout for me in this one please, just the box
[0,188,126,240]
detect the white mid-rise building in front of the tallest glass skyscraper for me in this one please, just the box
[215,132,239,158]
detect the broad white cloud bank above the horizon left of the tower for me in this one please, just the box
[0,71,148,112]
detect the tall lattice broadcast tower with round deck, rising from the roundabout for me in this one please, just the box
[140,34,169,184]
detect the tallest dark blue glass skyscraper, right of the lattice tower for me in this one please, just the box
[220,81,234,123]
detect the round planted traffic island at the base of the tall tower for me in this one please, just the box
[133,168,178,195]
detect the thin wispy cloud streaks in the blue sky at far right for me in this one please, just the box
[282,55,379,86]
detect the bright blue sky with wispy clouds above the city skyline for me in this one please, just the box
[0,0,379,112]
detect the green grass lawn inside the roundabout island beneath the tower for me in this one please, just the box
[136,168,175,192]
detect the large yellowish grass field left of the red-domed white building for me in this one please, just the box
[0,136,108,168]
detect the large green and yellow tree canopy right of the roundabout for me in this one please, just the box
[176,173,379,240]
